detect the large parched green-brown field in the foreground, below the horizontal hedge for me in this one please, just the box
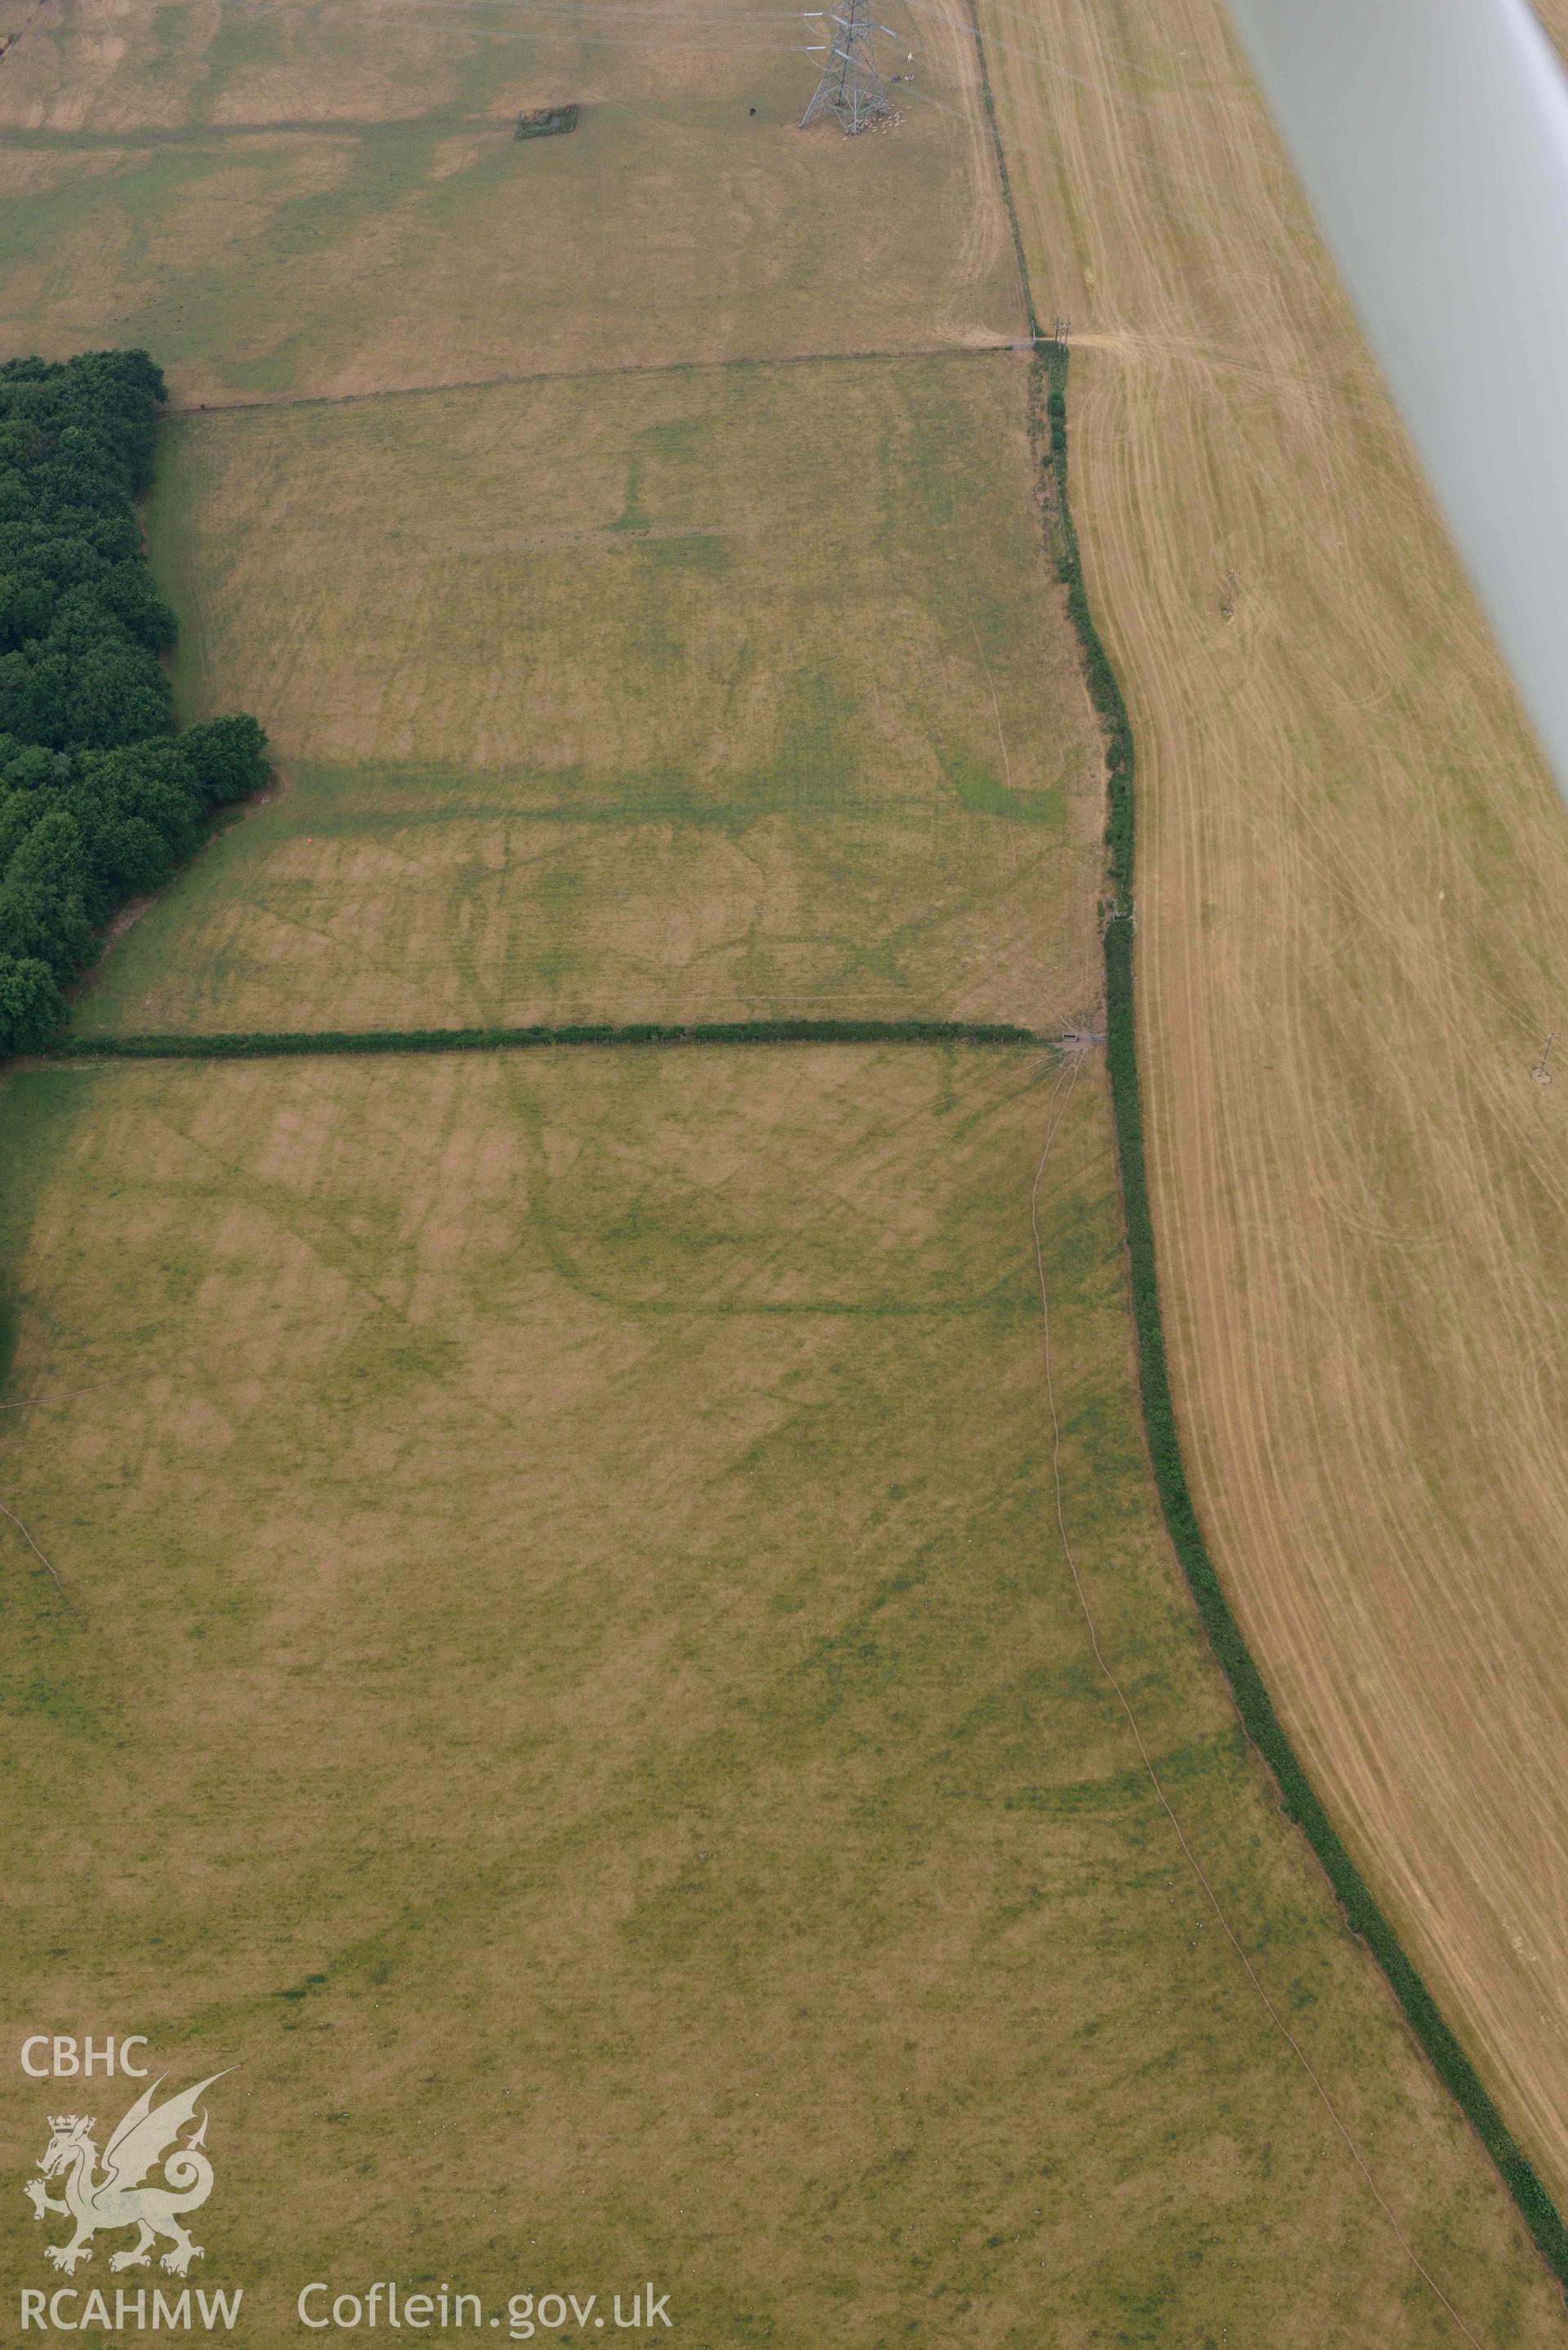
[0,1050,1558,2350]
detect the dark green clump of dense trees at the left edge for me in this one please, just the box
[0,350,268,1050]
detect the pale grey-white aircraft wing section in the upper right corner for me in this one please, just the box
[1229,0,1568,796]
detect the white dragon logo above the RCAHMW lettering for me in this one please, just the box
[24,2073,223,2277]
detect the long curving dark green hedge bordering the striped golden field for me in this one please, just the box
[1032,346,1568,2284]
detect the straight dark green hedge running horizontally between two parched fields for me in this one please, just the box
[40,1020,1060,1060]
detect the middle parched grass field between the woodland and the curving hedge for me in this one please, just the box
[82,355,1100,1029]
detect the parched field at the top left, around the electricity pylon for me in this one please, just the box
[0,0,1025,402]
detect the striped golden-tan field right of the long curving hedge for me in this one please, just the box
[985,0,1568,2200]
